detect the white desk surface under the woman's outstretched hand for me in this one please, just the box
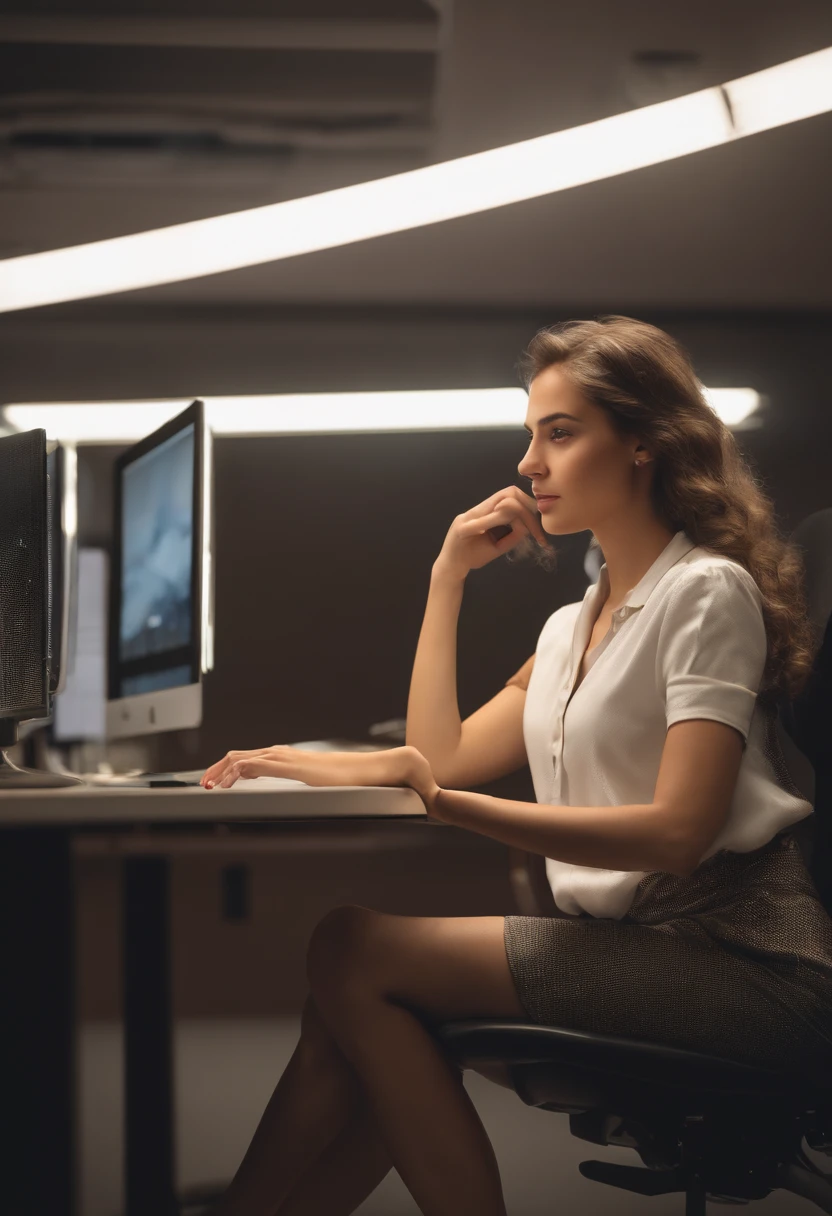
[0,778,427,831]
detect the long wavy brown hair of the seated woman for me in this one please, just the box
[518,315,819,704]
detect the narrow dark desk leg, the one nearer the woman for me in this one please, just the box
[123,857,178,1216]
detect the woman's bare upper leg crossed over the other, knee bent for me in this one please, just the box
[308,907,525,1216]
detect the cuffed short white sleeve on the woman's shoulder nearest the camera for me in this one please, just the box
[657,563,768,741]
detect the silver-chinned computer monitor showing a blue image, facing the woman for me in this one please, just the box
[106,401,214,738]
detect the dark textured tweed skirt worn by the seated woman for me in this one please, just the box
[505,833,832,1070]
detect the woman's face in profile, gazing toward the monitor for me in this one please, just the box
[517,365,648,536]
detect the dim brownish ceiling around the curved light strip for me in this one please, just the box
[0,0,832,311]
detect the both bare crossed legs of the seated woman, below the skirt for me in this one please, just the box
[212,906,527,1216]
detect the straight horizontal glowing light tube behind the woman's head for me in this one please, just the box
[4,388,759,444]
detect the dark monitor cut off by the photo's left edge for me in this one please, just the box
[0,429,82,788]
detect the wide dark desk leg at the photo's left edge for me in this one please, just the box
[0,828,77,1216]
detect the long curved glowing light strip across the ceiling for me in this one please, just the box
[0,47,832,313]
